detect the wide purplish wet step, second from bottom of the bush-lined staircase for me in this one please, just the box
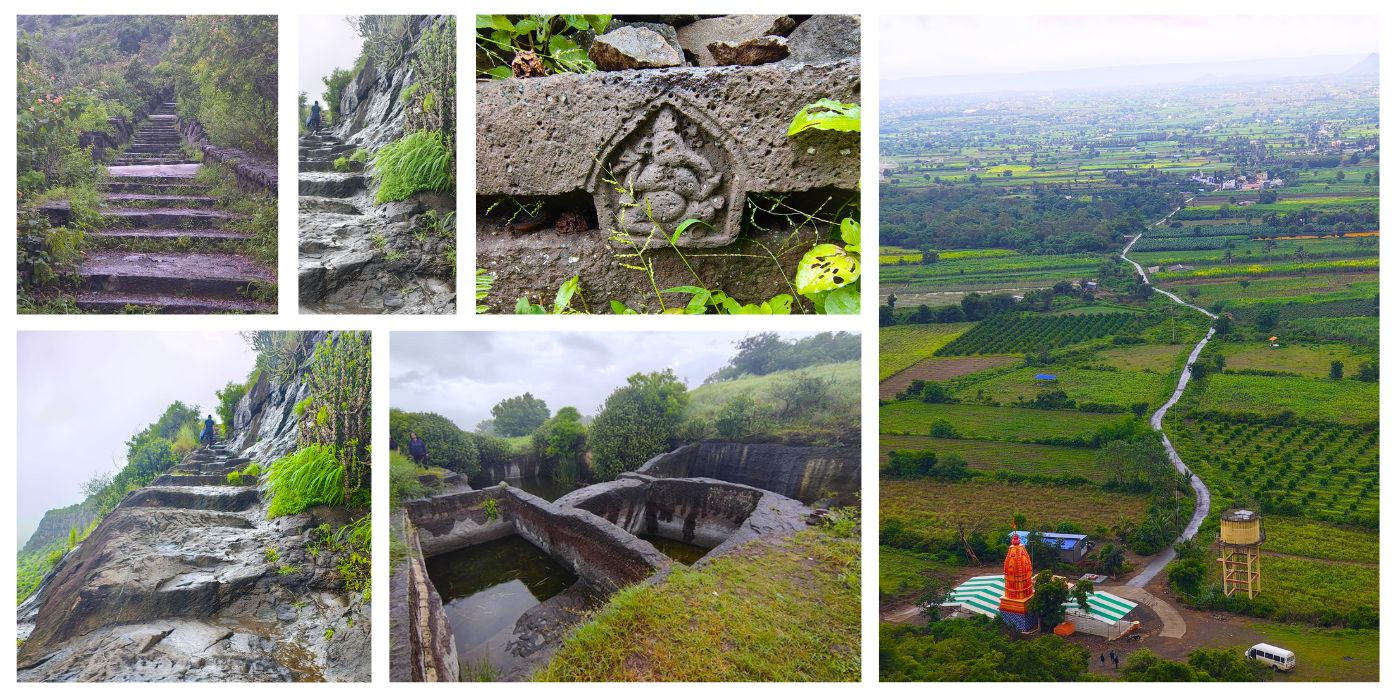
[78,251,276,297]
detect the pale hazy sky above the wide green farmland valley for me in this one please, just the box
[881,15,1380,80]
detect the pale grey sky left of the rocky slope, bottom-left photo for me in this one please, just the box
[17,332,255,546]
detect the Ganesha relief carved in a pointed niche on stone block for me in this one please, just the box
[594,101,743,248]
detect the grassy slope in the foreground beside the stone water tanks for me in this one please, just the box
[535,529,861,682]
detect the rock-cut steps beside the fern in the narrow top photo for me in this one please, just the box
[297,130,456,314]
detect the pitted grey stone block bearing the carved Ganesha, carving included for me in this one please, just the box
[476,60,860,248]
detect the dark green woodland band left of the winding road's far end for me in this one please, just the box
[881,186,1179,255]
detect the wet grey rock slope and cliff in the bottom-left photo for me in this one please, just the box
[18,333,371,680]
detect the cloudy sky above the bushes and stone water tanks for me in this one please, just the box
[389,332,811,430]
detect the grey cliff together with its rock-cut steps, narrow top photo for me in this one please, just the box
[298,15,456,314]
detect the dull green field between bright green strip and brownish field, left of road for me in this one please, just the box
[879,435,1106,482]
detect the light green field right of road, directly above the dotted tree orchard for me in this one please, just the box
[1194,374,1380,423]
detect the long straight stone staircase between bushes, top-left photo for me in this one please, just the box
[77,102,276,314]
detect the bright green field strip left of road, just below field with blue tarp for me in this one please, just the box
[879,400,1126,442]
